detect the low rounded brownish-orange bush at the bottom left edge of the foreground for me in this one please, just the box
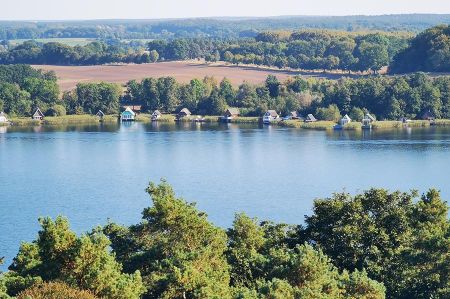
[17,282,97,299]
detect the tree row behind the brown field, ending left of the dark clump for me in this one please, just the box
[149,30,410,71]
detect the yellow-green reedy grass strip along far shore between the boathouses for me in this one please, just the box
[6,113,450,130]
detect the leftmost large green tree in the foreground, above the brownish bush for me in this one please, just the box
[10,217,145,299]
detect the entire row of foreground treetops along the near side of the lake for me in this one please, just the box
[0,181,450,299]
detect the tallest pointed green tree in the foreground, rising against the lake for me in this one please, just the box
[108,181,230,298]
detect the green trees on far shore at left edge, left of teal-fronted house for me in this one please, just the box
[0,65,122,116]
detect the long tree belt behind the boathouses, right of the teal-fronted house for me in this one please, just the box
[124,73,450,121]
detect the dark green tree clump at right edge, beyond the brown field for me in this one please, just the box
[389,25,450,73]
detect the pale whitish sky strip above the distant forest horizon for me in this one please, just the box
[0,0,450,20]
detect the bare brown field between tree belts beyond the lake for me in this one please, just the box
[34,61,362,90]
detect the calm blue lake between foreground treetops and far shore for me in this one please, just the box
[0,123,450,269]
